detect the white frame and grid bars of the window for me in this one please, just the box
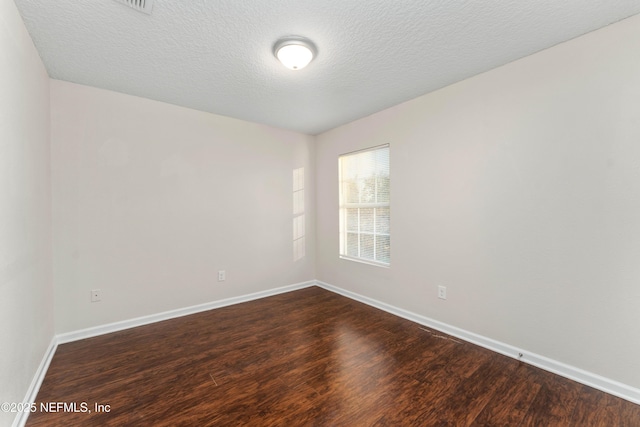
[338,144,391,268]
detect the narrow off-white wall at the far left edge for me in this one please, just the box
[0,0,53,425]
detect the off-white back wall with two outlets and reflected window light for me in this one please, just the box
[51,80,315,333]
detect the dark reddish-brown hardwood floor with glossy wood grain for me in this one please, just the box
[27,287,640,426]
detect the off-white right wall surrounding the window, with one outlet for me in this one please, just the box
[316,16,640,387]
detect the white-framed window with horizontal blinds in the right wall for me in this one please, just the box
[338,145,391,266]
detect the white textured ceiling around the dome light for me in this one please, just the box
[15,0,640,134]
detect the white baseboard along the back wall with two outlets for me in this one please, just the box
[57,280,316,344]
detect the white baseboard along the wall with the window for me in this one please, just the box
[316,280,640,405]
